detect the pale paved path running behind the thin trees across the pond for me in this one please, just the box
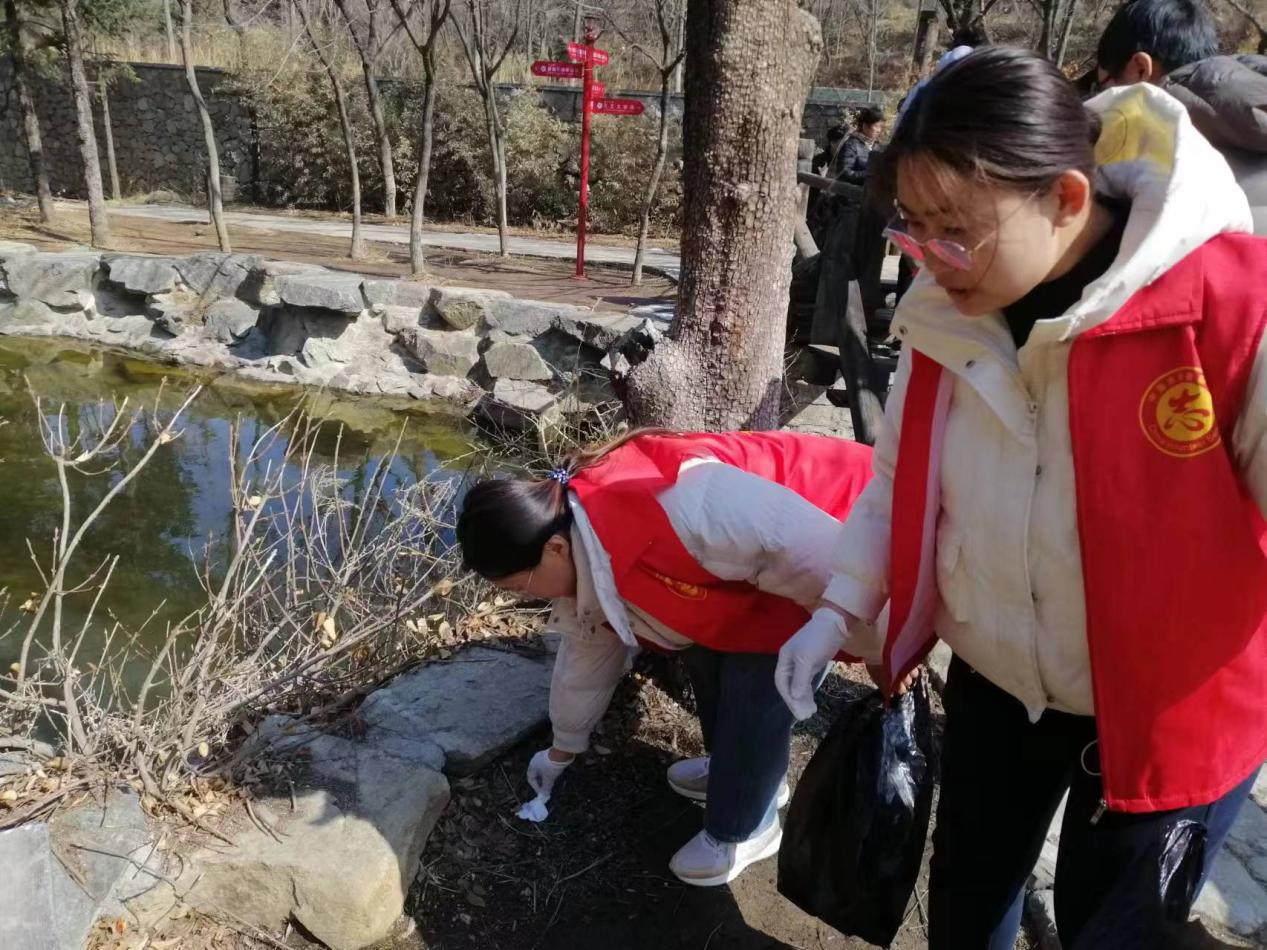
[110,204,682,280]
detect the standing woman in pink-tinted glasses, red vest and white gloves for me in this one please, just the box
[779,48,1267,950]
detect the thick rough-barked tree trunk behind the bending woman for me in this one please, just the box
[626,0,822,431]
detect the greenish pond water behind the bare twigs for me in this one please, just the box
[0,338,476,671]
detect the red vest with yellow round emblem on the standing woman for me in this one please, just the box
[886,236,1267,812]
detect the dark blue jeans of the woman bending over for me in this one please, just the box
[683,646,793,842]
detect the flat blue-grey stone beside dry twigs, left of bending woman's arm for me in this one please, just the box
[360,647,554,775]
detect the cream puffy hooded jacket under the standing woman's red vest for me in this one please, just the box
[824,85,1267,719]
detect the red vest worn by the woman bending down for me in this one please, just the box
[569,432,872,654]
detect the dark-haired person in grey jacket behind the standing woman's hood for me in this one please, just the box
[1096,0,1267,236]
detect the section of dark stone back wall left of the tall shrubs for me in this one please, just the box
[0,58,256,200]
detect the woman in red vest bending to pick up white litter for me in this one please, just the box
[457,431,870,885]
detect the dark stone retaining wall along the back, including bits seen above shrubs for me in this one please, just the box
[0,58,893,201]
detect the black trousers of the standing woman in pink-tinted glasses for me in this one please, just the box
[929,657,1254,950]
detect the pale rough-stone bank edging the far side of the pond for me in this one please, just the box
[0,242,668,428]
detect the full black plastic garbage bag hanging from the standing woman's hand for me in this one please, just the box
[779,678,934,946]
